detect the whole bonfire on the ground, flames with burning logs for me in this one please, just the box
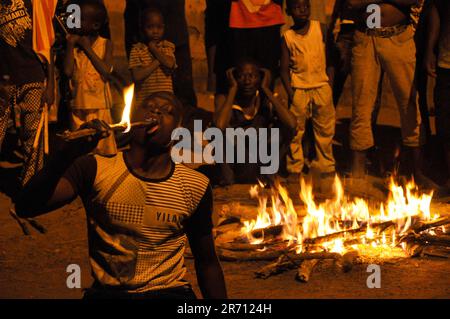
[216,176,450,281]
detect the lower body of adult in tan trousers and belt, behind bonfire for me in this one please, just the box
[347,0,438,189]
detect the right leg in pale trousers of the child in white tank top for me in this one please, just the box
[311,85,336,173]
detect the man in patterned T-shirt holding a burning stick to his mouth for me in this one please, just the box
[16,92,226,299]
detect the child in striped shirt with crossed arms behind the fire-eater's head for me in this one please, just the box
[129,8,176,105]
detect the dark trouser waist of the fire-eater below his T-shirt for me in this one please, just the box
[83,284,197,300]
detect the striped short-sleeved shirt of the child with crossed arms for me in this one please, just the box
[129,40,175,105]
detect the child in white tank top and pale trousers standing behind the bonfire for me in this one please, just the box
[281,0,335,180]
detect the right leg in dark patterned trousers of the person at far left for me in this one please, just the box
[16,83,44,185]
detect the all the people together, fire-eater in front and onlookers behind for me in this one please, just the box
[0,0,450,298]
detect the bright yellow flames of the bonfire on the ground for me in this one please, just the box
[241,176,439,254]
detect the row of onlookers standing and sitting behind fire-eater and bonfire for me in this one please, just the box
[0,0,449,189]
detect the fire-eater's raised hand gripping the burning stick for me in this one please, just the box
[61,119,111,160]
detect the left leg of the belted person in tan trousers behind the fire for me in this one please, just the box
[350,31,381,178]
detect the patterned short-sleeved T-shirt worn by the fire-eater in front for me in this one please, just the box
[64,153,212,293]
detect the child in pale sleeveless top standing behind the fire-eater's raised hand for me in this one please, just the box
[64,0,117,155]
